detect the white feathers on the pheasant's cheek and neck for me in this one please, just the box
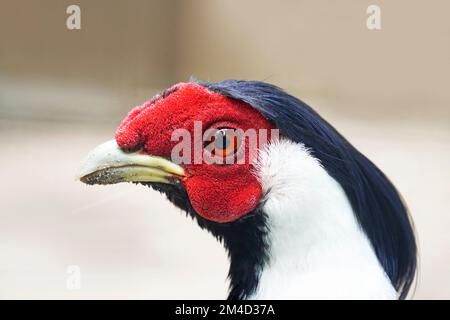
[250,139,397,299]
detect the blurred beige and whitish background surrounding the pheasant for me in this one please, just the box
[0,0,450,299]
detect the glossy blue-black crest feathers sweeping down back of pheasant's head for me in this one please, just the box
[199,80,417,299]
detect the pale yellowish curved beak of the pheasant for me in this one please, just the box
[77,140,184,184]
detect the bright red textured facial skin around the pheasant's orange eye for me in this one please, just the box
[115,83,274,223]
